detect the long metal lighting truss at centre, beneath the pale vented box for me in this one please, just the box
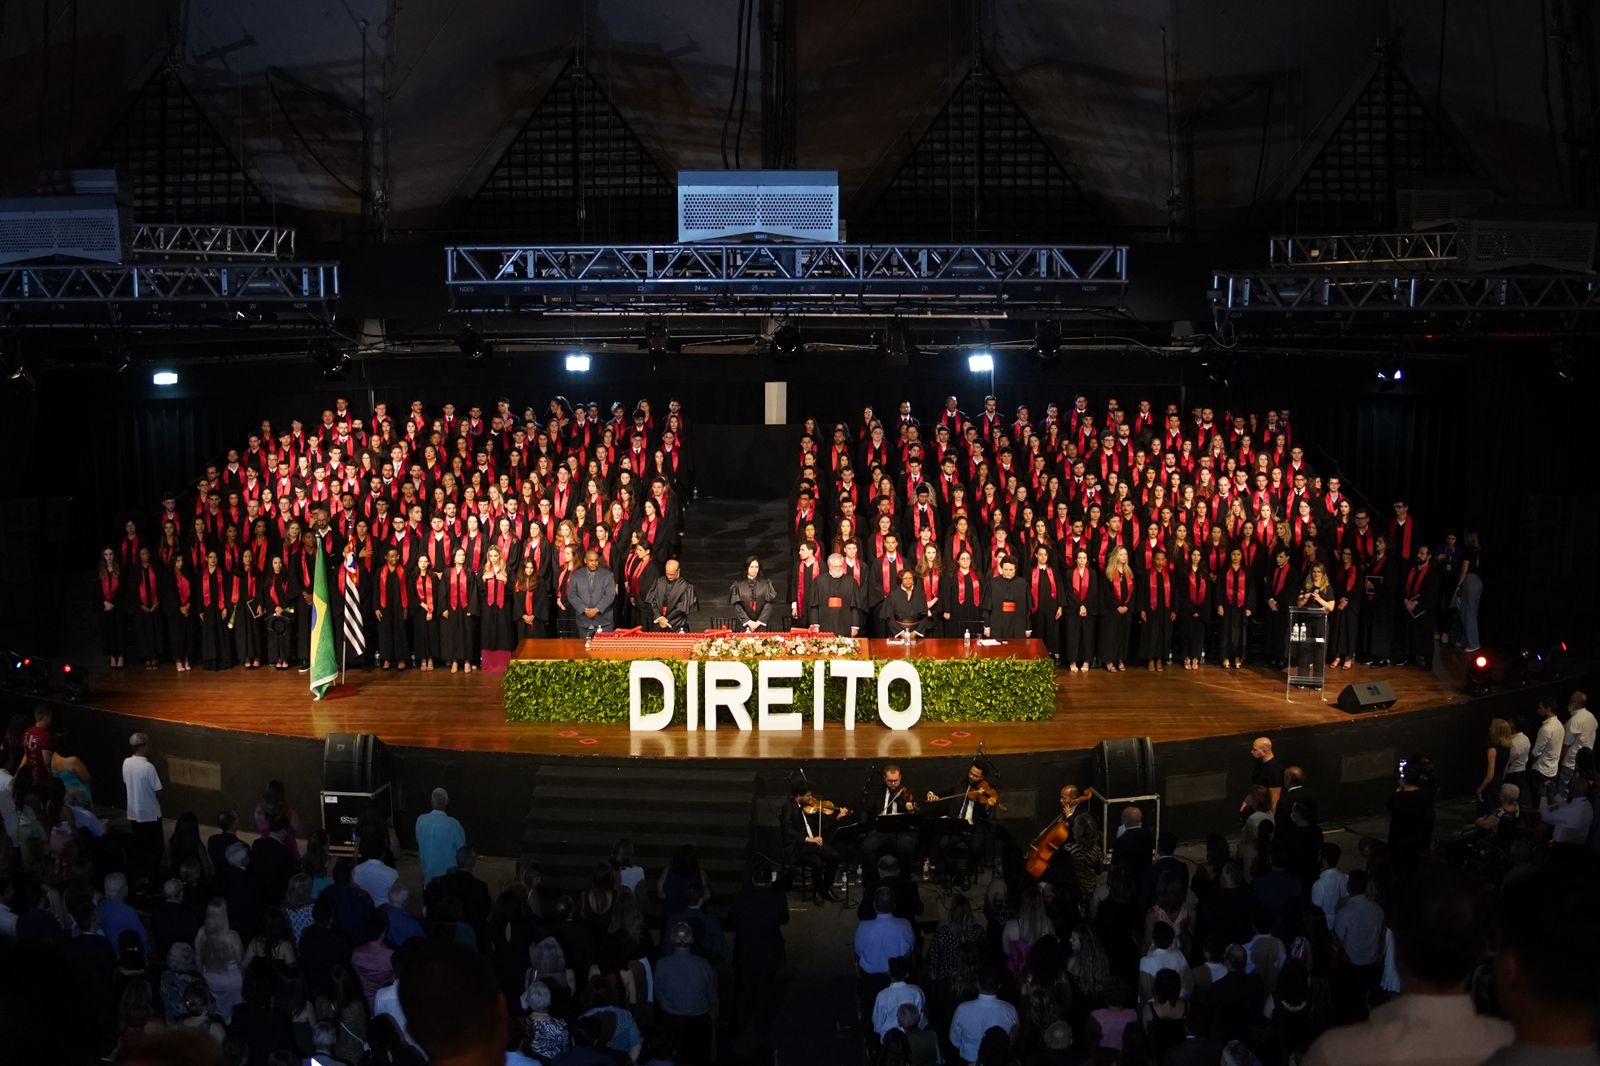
[445,243,1128,314]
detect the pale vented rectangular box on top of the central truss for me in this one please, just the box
[678,170,838,242]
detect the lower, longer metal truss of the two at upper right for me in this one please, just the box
[1211,271,1600,327]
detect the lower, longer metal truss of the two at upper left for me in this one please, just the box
[0,262,339,307]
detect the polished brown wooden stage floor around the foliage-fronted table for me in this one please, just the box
[85,648,1467,760]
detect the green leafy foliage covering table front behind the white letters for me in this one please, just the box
[502,658,1056,725]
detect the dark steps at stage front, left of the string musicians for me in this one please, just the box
[522,762,757,893]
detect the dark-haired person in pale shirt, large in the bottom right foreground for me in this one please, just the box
[1304,871,1512,1066]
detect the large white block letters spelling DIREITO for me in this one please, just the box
[627,659,922,733]
